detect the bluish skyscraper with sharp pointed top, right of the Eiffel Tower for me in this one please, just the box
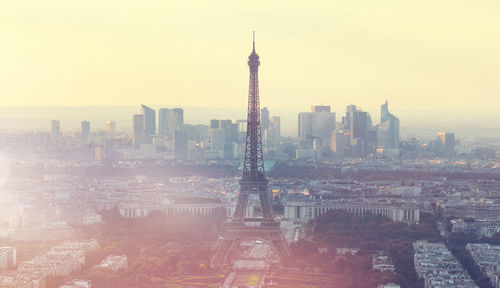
[377,101,399,149]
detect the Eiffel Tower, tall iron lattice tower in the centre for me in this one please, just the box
[211,32,290,266]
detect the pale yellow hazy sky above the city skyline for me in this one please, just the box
[0,0,500,111]
